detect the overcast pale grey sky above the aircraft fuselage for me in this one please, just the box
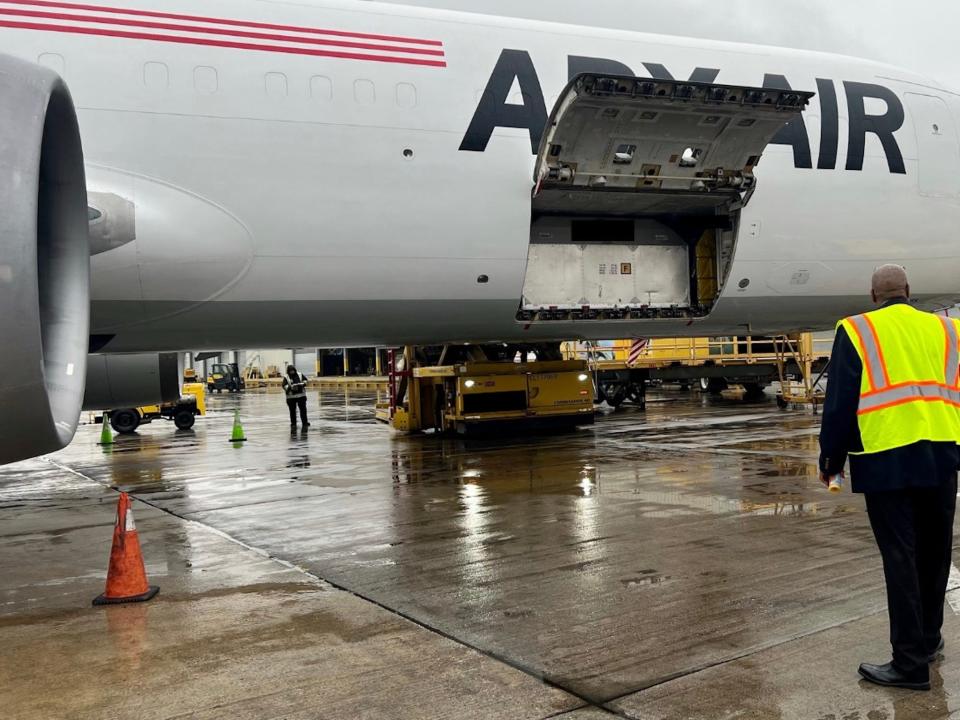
[387,0,960,91]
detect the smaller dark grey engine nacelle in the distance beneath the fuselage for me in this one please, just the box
[83,353,183,410]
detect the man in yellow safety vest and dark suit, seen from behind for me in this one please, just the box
[820,265,960,690]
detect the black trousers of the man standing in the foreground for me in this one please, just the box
[864,473,957,673]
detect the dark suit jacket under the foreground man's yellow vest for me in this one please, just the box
[820,300,960,492]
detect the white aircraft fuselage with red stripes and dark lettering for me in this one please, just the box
[0,0,960,352]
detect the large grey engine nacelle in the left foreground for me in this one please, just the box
[0,55,90,463]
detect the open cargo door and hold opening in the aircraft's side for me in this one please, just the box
[518,74,813,322]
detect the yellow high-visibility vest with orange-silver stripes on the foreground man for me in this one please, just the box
[837,303,960,455]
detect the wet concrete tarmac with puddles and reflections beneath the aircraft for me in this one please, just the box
[0,390,960,720]
